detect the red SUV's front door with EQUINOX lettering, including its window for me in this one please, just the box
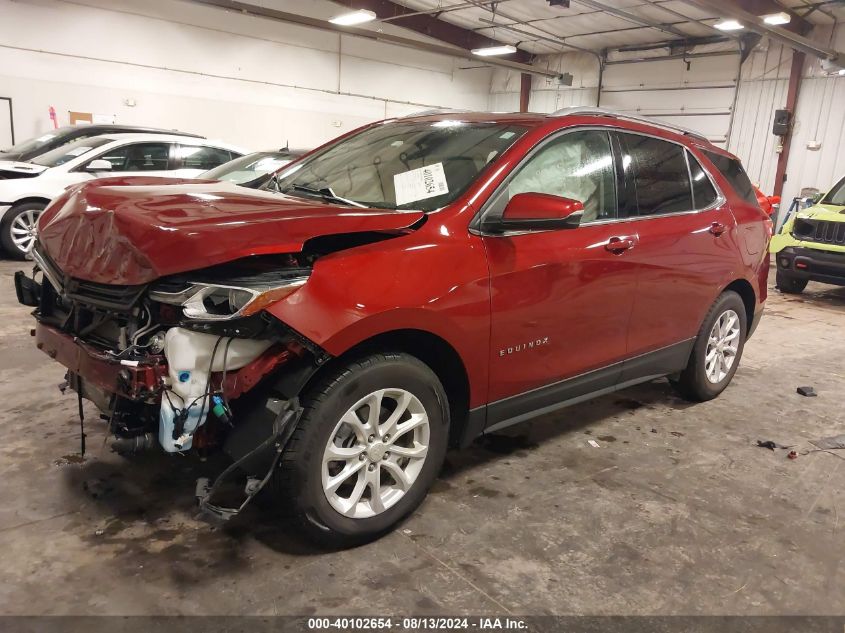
[482,129,636,430]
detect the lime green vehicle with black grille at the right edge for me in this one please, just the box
[769,172,845,294]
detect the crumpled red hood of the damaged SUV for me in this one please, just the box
[39,177,424,285]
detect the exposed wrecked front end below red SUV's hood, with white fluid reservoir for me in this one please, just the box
[15,254,328,519]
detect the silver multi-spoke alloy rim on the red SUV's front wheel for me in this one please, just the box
[322,389,430,519]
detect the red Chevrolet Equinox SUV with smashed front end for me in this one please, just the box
[16,109,771,545]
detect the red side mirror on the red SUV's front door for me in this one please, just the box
[485,192,584,231]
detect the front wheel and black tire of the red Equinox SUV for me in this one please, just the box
[274,353,449,548]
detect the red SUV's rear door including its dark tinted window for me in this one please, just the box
[615,132,737,382]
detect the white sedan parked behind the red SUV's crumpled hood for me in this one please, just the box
[0,134,247,259]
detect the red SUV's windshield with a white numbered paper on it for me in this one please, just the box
[275,120,527,211]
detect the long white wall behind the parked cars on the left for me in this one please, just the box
[0,0,491,149]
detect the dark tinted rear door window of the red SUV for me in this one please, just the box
[619,133,694,216]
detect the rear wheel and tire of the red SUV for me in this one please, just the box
[672,290,748,402]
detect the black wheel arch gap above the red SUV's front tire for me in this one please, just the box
[302,328,470,444]
